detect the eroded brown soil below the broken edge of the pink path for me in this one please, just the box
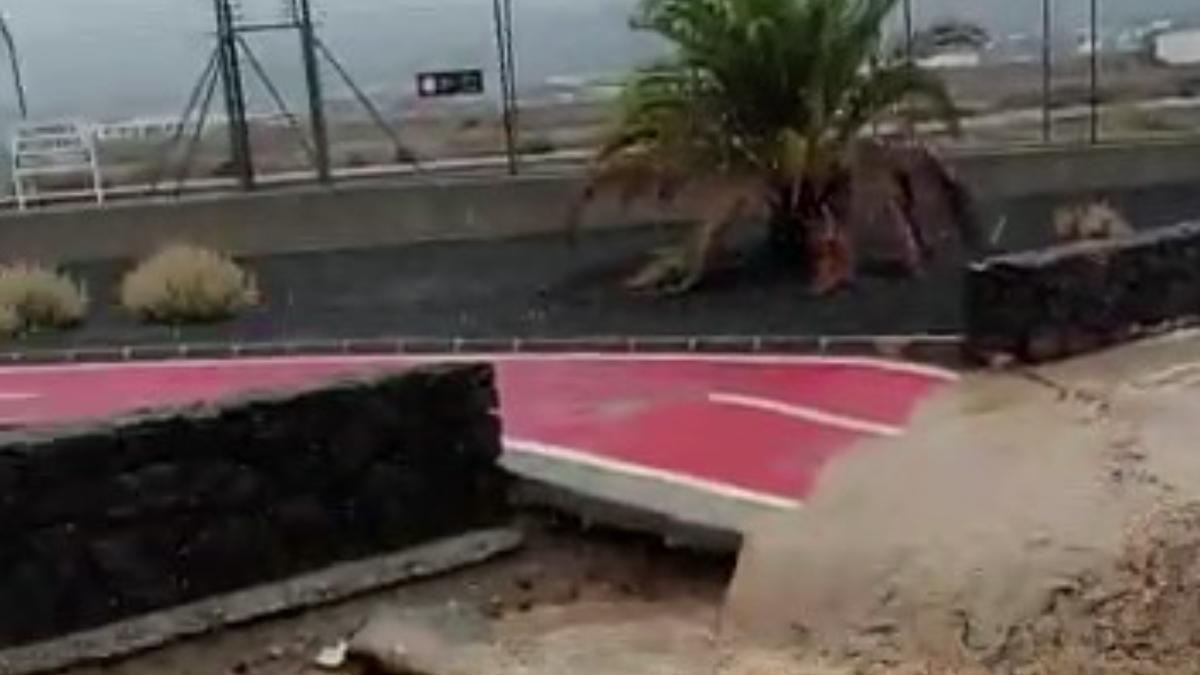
[68,511,732,675]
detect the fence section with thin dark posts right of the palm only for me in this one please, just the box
[905,0,1200,145]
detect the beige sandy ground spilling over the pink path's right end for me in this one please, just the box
[726,335,1200,673]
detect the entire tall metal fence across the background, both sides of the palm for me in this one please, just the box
[0,0,1200,198]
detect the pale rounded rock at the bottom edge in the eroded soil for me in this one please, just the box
[347,611,452,675]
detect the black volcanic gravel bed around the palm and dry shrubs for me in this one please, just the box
[2,180,1200,348]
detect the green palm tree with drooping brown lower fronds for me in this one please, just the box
[571,0,967,292]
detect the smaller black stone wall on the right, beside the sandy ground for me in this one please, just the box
[965,222,1200,362]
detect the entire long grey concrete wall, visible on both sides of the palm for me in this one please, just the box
[0,142,1200,262]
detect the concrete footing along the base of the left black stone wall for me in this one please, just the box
[0,530,522,675]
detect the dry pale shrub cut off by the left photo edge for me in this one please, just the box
[0,263,88,335]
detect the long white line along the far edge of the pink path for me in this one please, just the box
[0,352,959,382]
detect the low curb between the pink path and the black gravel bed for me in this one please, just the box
[0,334,970,368]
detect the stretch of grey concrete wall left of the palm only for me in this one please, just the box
[0,173,670,262]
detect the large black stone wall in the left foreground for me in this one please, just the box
[0,365,504,647]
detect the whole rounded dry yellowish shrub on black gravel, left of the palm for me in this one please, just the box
[121,244,259,323]
